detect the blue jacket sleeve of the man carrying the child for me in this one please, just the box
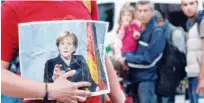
[125,28,166,65]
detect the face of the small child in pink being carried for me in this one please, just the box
[121,11,133,25]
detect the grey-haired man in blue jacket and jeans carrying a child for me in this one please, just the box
[120,0,165,103]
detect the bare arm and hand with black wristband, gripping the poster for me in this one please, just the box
[1,61,90,102]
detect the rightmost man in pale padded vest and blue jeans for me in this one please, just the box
[181,0,204,103]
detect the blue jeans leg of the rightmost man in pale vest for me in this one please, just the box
[188,77,199,103]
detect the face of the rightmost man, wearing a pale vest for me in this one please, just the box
[181,0,198,18]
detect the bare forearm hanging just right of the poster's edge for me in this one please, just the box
[105,55,125,103]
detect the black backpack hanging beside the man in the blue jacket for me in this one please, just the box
[156,26,186,96]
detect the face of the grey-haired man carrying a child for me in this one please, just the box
[136,4,153,24]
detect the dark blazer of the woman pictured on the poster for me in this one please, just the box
[44,55,97,91]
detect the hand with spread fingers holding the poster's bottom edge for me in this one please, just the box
[48,70,91,103]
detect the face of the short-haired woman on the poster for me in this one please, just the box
[58,37,75,58]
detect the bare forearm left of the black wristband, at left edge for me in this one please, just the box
[1,68,45,98]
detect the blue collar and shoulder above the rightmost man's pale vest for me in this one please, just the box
[186,10,204,32]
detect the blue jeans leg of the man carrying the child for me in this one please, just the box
[138,81,157,103]
